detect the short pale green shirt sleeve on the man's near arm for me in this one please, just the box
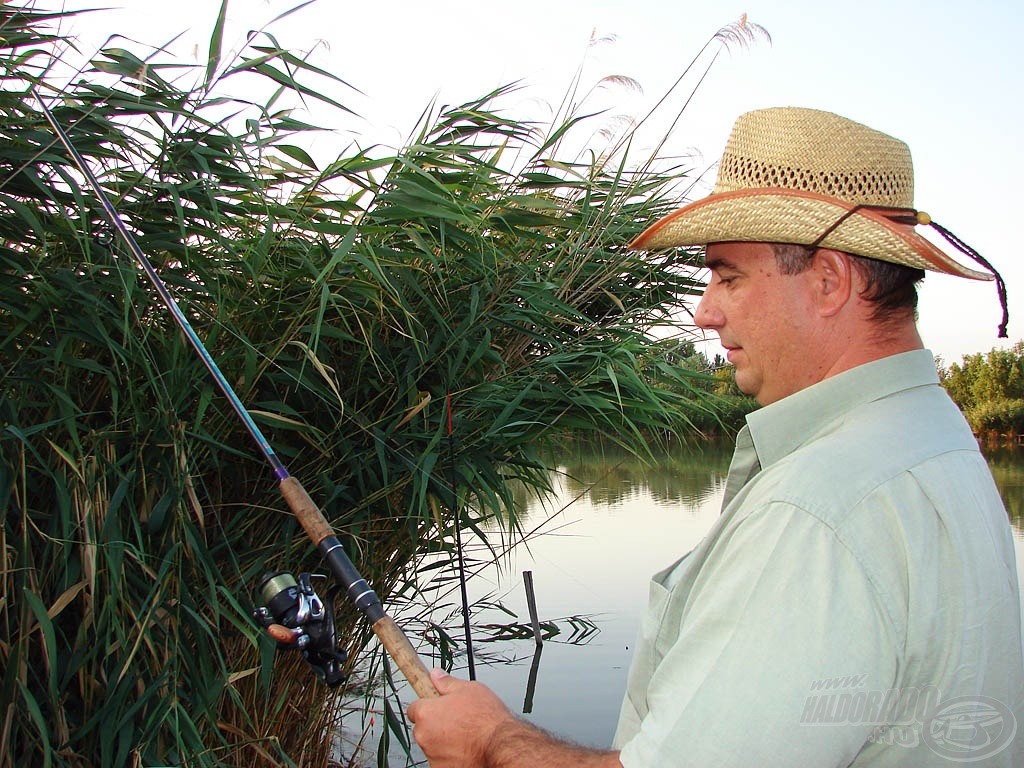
[621,502,898,768]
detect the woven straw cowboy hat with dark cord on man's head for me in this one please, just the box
[630,108,1001,283]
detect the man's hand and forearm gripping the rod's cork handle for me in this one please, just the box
[409,670,622,768]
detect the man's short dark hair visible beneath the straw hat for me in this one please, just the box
[771,243,925,323]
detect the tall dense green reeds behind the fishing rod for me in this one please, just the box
[0,2,758,768]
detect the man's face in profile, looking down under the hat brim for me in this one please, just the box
[693,243,822,406]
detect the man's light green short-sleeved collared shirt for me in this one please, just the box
[614,350,1024,768]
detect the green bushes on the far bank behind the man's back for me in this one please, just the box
[937,341,1024,441]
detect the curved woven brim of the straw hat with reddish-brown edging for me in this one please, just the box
[630,187,992,280]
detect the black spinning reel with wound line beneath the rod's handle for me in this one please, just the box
[253,570,347,688]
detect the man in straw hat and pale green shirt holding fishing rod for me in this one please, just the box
[409,109,1024,768]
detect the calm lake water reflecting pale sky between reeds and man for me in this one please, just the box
[354,442,1024,764]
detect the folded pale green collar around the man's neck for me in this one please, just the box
[746,349,939,467]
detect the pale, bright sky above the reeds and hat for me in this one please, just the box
[36,0,1024,364]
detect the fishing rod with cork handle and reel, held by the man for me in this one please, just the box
[29,86,437,698]
